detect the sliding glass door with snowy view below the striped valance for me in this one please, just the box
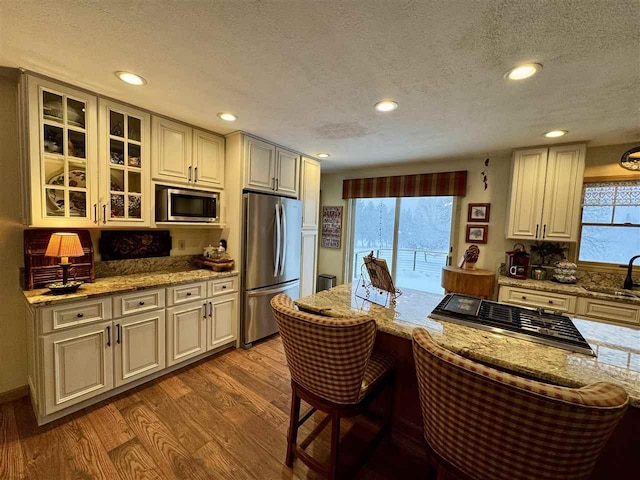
[351,196,454,293]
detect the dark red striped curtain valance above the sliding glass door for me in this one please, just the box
[342,170,467,198]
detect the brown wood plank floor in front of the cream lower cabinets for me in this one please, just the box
[0,337,426,480]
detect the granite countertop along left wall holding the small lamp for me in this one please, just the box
[23,268,238,307]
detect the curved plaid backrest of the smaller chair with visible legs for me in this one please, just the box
[271,294,376,404]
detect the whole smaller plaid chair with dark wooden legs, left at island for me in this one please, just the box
[271,294,393,478]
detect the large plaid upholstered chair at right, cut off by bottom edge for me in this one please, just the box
[413,329,628,480]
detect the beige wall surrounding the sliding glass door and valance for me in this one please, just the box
[318,154,513,283]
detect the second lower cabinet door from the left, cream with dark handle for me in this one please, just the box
[113,309,166,387]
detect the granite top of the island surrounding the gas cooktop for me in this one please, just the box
[296,284,640,408]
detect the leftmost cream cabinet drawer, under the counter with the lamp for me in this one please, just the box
[40,298,111,333]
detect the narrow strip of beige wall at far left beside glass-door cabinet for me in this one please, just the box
[0,72,27,393]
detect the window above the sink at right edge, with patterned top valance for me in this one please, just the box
[578,180,640,265]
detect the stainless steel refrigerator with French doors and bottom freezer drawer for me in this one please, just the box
[242,193,302,347]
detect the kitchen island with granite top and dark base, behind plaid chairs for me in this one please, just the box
[296,284,640,478]
